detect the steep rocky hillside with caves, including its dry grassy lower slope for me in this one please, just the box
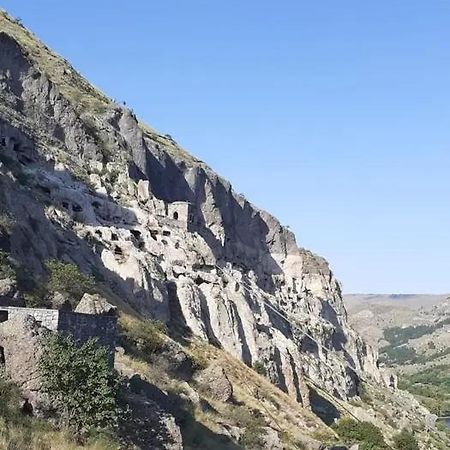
[0,9,447,450]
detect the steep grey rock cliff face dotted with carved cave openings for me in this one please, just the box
[0,14,381,399]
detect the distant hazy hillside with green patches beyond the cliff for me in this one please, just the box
[345,295,450,426]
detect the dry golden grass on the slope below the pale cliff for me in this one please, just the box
[117,334,335,449]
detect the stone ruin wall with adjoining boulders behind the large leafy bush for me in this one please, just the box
[0,294,117,414]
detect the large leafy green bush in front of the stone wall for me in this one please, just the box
[39,334,119,436]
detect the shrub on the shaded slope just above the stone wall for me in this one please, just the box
[45,259,95,302]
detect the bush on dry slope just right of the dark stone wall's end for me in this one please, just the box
[119,317,167,361]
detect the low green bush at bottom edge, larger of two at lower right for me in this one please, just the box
[333,417,387,450]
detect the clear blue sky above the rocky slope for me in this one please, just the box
[1,0,450,293]
